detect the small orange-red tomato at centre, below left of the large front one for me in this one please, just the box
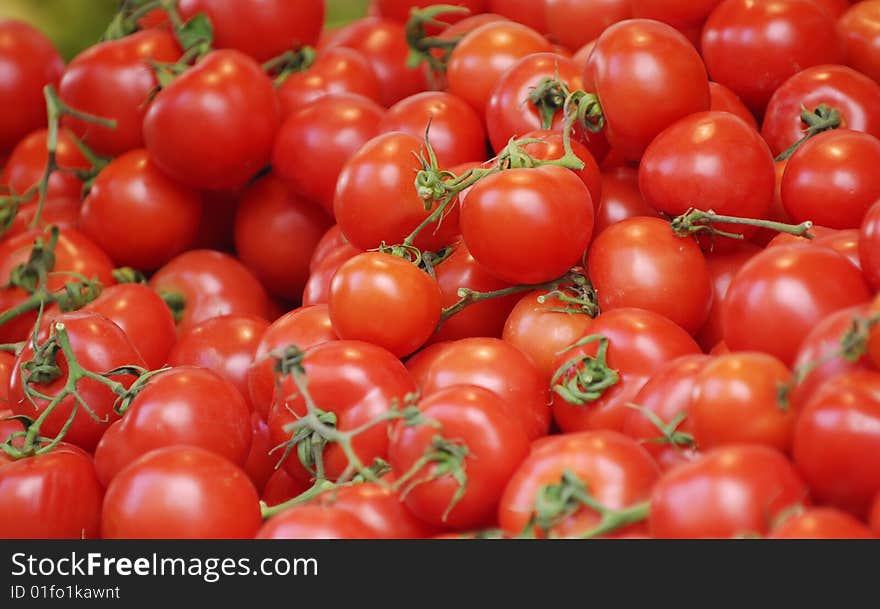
[327,252,442,357]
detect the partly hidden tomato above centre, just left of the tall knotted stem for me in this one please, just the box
[379,91,486,169]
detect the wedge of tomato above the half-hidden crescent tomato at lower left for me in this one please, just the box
[168,315,269,405]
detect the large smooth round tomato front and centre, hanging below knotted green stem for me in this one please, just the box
[461,165,594,284]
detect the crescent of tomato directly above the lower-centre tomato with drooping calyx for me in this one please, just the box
[414,338,550,436]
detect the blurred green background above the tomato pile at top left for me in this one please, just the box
[0,0,369,59]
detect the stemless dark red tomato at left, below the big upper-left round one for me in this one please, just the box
[79,149,202,271]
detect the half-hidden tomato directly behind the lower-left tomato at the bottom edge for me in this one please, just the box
[95,366,252,487]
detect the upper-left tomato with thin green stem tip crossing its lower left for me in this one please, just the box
[58,29,181,156]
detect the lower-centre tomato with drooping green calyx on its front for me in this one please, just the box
[388,386,529,530]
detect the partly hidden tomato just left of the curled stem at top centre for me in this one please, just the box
[321,17,427,107]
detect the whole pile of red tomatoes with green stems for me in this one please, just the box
[0,0,880,538]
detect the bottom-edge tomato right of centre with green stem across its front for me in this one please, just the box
[498,431,660,537]
